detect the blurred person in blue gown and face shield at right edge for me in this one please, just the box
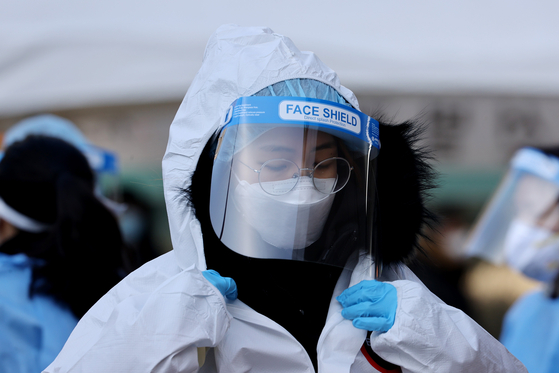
[466,147,559,372]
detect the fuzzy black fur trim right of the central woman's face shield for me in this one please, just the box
[373,116,438,264]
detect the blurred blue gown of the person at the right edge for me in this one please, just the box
[501,291,559,373]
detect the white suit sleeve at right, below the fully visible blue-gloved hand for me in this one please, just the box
[370,280,527,373]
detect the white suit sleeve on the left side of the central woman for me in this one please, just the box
[44,268,231,373]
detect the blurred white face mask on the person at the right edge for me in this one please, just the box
[504,220,559,282]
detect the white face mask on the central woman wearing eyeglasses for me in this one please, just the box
[234,177,336,250]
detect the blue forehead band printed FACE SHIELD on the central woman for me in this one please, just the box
[223,97,380,149]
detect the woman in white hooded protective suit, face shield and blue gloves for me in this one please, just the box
[46,25,525,373]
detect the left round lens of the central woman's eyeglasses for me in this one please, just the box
[258,159,299,196]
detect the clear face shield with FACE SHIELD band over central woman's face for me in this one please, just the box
[210,97,379,267]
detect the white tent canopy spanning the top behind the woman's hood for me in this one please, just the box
[0,0,559,117]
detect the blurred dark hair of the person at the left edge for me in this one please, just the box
[0,135,124,318]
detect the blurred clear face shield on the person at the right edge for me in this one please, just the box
[466,148,559,281]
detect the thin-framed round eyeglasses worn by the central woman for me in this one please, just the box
[239,157,353,196]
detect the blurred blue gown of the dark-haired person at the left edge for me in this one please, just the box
[0,253,78,373]
